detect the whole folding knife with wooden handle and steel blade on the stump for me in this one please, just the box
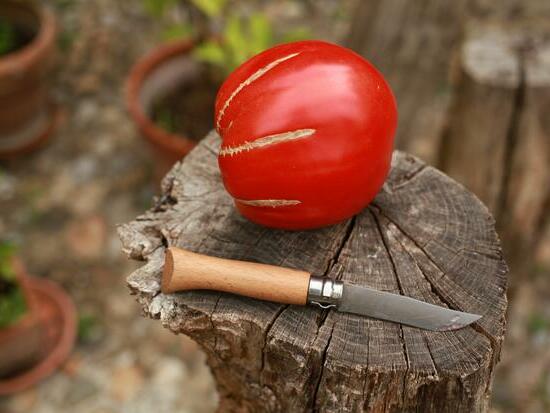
[161,247,481,331]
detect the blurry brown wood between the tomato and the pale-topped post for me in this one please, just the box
[347,0,466,164]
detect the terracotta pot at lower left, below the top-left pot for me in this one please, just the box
[0,261,77,396]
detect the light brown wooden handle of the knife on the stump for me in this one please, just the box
[161,247,310,305]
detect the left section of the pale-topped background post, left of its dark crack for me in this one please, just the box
[440,29,523,214]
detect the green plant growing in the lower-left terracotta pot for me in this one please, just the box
[0,242,27,328]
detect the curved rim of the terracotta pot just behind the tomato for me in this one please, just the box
[126,39,197,155]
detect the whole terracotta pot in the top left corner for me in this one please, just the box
[0,0,56,158]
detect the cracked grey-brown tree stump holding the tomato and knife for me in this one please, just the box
[119,133,507,413]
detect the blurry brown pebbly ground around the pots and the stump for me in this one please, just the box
[0,0,550,413]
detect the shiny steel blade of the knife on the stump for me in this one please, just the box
[338,284,481,331]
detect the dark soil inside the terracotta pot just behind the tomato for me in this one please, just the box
[151,70,220,141]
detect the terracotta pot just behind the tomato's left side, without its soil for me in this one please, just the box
[126,40,205,176]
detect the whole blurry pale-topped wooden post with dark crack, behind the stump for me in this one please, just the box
[441,23,550,290]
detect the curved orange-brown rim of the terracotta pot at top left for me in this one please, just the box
[0,0,57,77]
